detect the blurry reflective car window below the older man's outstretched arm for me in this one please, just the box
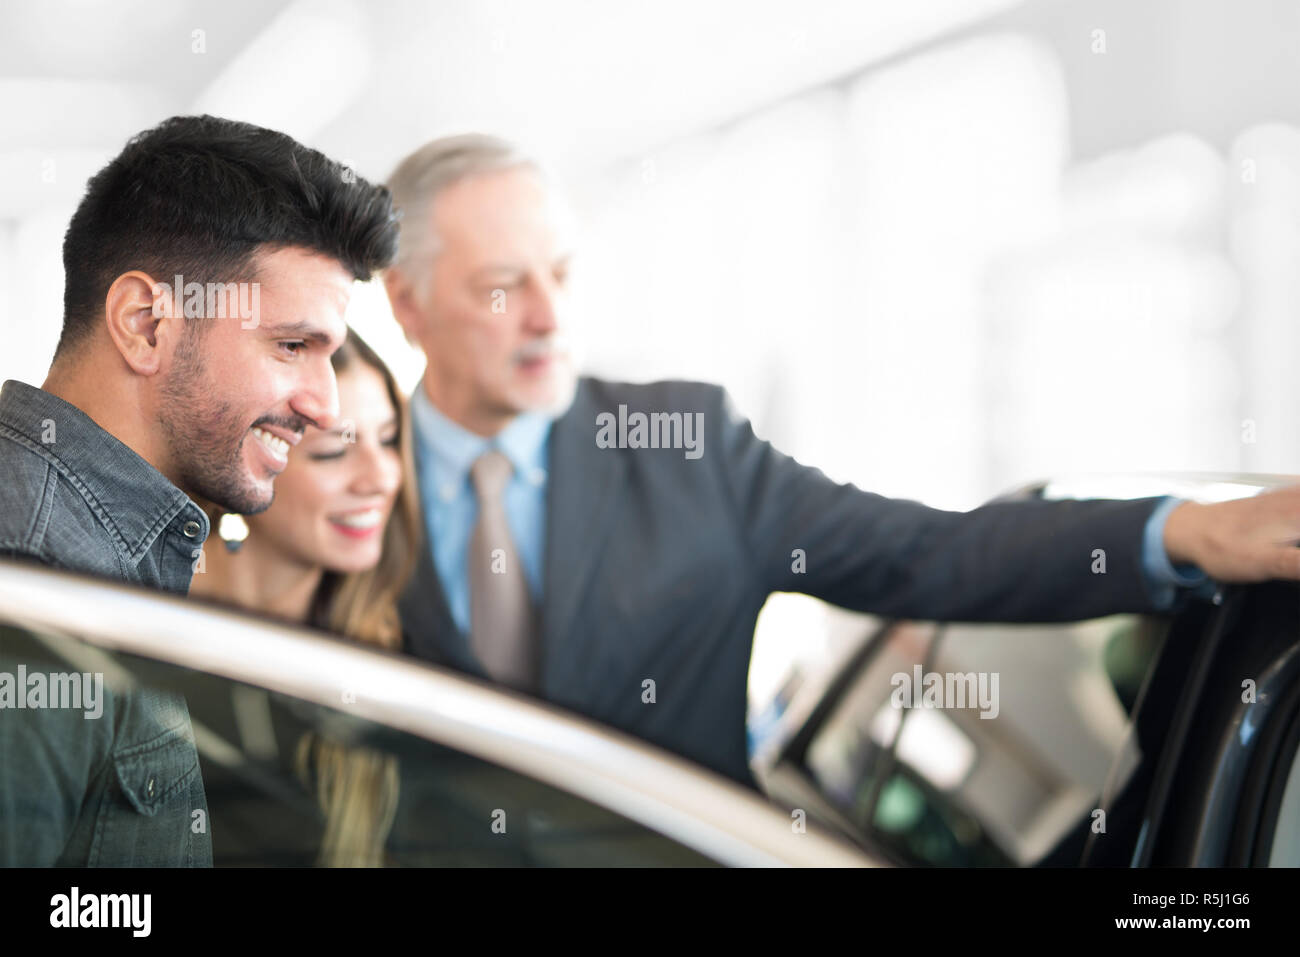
[803,615,1165,866]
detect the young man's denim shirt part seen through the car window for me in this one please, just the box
[0,623,212,867]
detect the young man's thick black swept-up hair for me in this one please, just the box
[57,116,398,352]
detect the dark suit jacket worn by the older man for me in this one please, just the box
[402,378,1158,785]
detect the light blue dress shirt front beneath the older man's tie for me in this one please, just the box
[411,382,554,635]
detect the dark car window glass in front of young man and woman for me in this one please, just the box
[0,627,712,866]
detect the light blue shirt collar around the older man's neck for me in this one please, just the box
[411,380,554,498]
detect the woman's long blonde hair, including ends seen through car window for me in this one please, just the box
[211,329,424,867]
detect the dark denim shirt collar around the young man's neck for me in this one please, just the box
[0,380,209,563]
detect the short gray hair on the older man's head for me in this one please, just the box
[386,133,541,272]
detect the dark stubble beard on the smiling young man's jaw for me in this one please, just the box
[159,330,273,515]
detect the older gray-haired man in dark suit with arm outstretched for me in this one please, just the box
[385,135,1300,785]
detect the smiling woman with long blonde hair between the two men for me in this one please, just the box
[190,330,421,866]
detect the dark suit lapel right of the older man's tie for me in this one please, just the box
[542,380,627,697]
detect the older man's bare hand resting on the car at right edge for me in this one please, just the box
[1165,485,1300,583]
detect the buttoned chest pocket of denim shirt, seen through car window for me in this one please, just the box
[90,728,202,867]
